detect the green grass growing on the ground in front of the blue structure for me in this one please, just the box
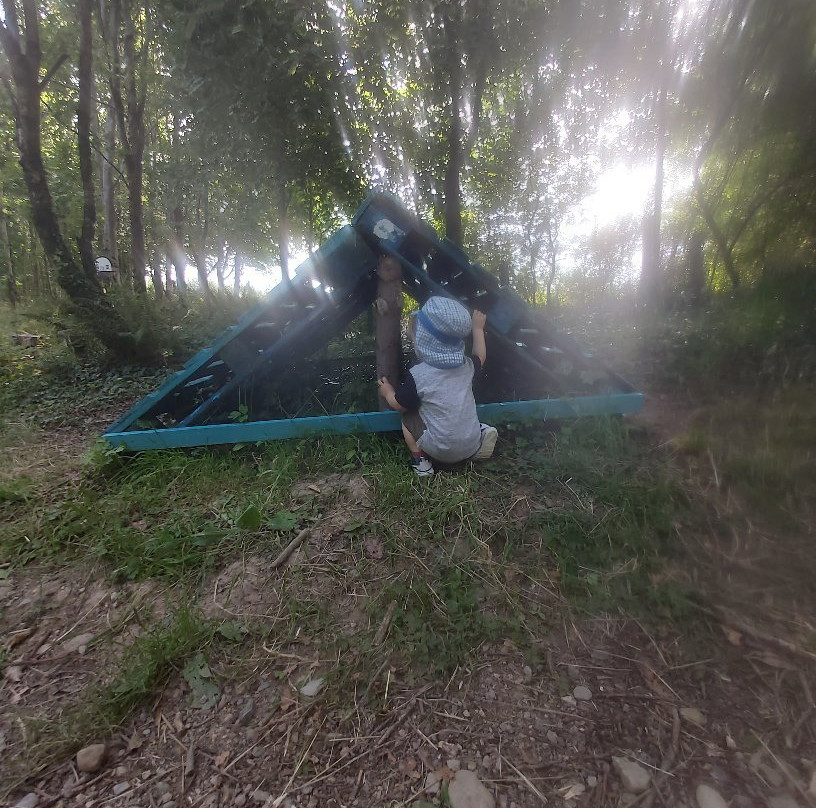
[0,318,700,784]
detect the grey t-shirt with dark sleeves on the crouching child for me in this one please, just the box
[396,357,481,463]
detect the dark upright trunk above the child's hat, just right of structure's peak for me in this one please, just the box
[443,8,464,246]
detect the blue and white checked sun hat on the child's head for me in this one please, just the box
[411,297,472,368]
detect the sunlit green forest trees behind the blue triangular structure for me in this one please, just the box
[0,0,816,364]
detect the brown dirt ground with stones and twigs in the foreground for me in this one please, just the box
[0,395,816,808]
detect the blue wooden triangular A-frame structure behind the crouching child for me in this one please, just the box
[104,193,643,450]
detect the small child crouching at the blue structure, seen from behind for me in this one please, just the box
[377,297,498,477]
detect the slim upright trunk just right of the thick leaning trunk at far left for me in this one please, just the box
[77,0,96,279]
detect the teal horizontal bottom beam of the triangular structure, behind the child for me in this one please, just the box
[103,393,643,451]
